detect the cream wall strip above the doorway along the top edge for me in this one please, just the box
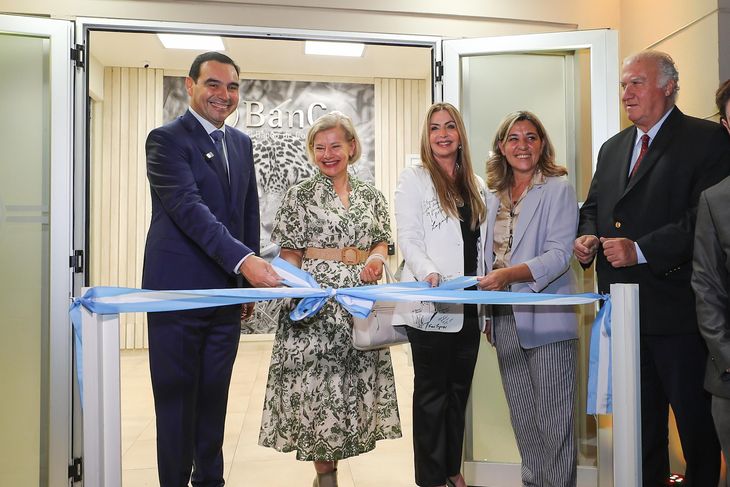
[0,0,619,37]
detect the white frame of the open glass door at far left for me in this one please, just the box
[0,11,74,487]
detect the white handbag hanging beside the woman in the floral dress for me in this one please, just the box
[352,263,408,350]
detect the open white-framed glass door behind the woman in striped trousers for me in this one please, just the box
[442,30,619,487]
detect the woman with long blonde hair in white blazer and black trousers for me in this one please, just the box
[395,103,486,487]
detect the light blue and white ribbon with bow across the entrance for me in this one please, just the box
[70,257,610,413]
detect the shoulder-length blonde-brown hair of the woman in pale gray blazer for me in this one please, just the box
[487,110,568,191]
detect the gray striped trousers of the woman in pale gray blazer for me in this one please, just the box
[493,306,577,487]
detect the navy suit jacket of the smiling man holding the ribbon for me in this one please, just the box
[142,111,260,300]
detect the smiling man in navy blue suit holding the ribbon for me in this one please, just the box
[142,52,281,487]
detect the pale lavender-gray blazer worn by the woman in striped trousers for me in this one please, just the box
[484,177,578,348]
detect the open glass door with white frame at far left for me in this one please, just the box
[0,15,72,487]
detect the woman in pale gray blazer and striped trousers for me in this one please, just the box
[478,111,578,487]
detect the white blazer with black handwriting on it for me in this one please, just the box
[395,165,487,332]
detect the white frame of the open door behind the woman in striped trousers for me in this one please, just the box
[442,29,620,485]
